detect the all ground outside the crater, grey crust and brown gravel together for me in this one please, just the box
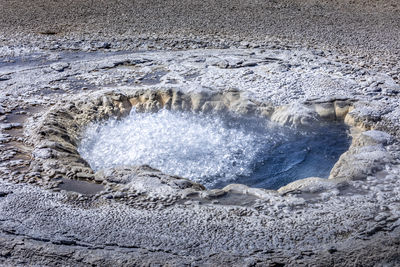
[0,0,400,266]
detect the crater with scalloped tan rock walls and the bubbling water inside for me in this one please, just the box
[29,89,369,198]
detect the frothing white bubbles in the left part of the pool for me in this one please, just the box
[79,110,281,187]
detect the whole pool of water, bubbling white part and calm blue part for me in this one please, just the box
[78,110,350,189]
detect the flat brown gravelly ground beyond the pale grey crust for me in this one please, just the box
[0,0,400,52]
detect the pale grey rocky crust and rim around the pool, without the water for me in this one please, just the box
[0,33,400,266]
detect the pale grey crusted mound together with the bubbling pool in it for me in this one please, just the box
[0,48,400,266]
